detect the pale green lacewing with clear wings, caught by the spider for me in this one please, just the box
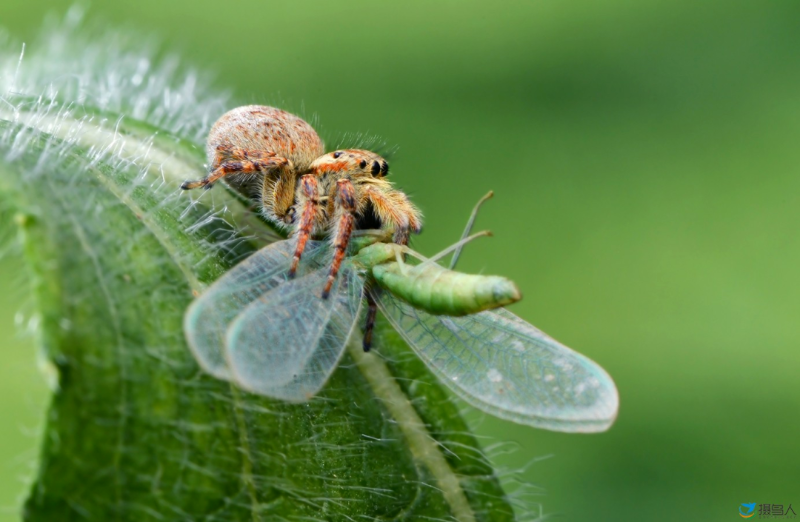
[184,231,619,432]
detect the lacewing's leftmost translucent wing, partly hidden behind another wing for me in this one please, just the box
[183,241,325,380]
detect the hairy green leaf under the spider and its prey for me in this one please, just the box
[0,12,534,521]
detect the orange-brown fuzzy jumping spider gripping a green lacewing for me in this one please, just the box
[181,105,422,298]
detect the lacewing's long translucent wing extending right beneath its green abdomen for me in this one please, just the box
[375,292,619,432]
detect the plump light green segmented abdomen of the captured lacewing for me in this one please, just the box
[372,262,522,316]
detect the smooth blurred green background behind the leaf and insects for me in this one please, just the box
[0,0,800,521]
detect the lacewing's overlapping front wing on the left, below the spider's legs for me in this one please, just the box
[226,265,364,402]
